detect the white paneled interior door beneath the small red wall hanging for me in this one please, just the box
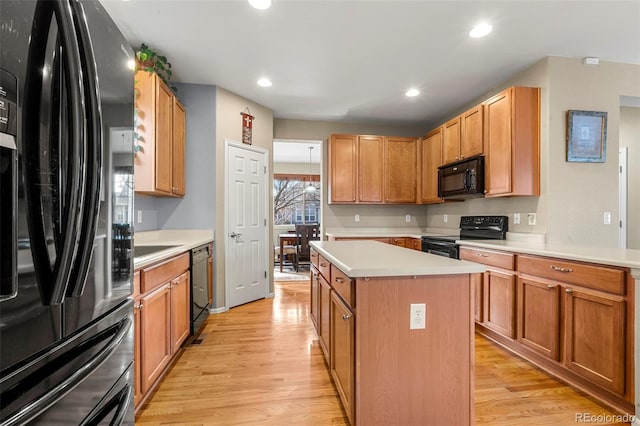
[225,141,269,308]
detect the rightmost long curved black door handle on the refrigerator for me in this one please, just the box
[66,2,102,297]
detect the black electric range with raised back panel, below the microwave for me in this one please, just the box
[422,216,509,259]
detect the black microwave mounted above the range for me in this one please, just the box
[438,156,484,199]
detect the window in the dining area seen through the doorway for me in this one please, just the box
[273,174,320,225]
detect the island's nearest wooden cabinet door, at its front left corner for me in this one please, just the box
[330,292,355,424]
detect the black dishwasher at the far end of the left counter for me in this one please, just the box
[191,244,211,335]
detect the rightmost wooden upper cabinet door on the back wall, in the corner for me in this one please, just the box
[383,136,418,204]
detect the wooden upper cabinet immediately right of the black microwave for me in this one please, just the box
[483,87,540,197]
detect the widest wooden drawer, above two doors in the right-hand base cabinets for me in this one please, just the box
[518,255,625,295]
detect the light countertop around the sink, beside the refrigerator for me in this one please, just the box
[133,229,213,269]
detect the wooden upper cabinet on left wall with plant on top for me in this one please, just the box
[134,71,185,196]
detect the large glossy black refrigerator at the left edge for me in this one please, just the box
[0,0,134,425]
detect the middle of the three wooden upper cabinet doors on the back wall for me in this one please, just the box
[358,136,385,203]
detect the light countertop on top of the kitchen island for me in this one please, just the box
[310,241,485,278]
